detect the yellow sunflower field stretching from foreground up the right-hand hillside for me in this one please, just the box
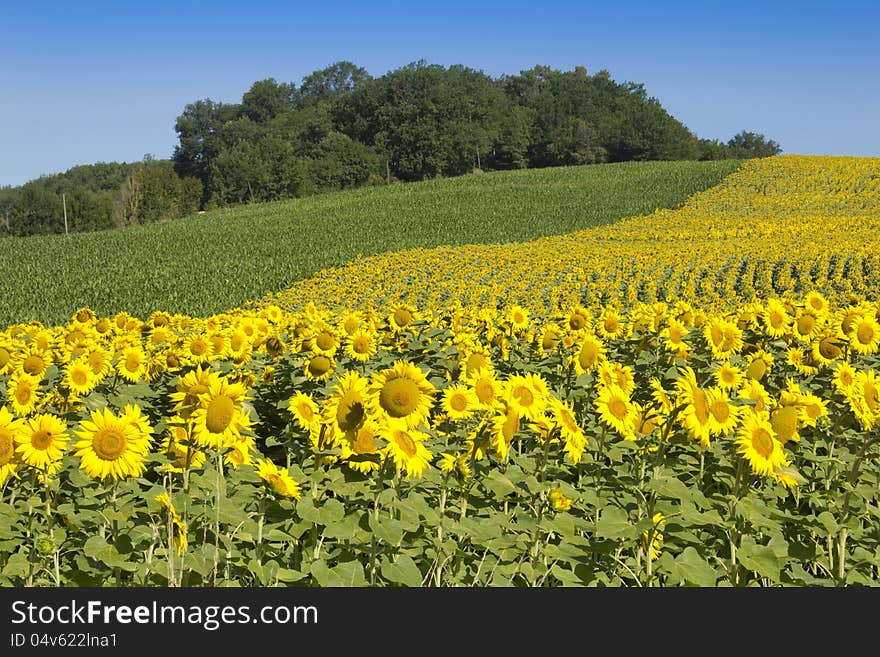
[0,156,880,587]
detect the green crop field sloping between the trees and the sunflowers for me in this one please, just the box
[0,161,739,326]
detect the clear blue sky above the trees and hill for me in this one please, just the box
[0,0,880,186]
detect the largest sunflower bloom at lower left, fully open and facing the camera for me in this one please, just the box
[73,407,150,479]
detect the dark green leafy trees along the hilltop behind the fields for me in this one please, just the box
[0,61,781,235]
